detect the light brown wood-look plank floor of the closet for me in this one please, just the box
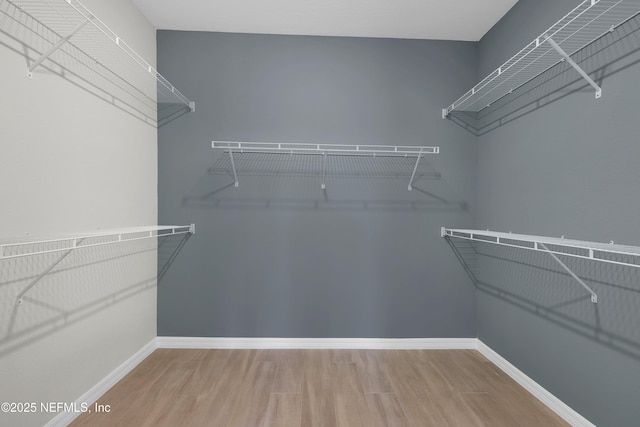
[71,349,568,427]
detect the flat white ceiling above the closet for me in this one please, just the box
[133,0,517,41]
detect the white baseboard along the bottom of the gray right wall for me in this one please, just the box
[477,339,596,427]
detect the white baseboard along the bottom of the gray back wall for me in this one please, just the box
[157,337,477,350]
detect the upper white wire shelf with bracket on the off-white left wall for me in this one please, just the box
[0,0,195,111]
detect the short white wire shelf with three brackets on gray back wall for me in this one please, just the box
[211,141,440,191]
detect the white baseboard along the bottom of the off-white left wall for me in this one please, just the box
[44,338,158,427]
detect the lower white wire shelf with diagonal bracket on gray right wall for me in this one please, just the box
[440,227,640,303]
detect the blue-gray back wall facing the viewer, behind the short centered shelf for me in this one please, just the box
[158,31,477,337]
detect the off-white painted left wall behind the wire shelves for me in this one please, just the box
[0,0,157,426]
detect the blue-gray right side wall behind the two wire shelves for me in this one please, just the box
[475,0,640,427]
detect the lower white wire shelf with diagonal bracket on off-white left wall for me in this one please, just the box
[0,224,196,304]
